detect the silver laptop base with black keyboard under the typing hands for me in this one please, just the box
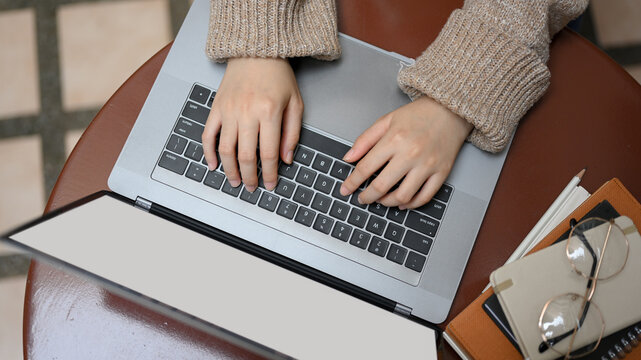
[109,0,507,323]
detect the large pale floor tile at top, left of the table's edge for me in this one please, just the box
[57,0,171,111]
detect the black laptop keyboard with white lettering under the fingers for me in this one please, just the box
[158,84,453,281]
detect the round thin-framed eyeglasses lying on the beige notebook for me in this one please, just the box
[539,218,630,359]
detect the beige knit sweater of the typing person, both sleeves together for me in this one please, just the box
[207,0,588,152]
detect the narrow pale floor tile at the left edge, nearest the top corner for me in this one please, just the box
[0,9,40,119]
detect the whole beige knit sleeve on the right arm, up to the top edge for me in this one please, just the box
[398,0,588,152]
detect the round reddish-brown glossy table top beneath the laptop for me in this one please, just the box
[24,0,641,359]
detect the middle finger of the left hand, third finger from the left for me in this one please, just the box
[238,120,258,192]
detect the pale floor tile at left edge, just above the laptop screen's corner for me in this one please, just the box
[0,136,45,245]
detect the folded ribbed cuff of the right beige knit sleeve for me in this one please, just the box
[398,10,550,152]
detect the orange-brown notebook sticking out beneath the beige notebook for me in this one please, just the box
[445,178,641,360]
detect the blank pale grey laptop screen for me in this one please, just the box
[11,196,436,359]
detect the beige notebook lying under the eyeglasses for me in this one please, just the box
[490,216,641,360]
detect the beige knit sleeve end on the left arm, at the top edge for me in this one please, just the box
[206,0,341,62]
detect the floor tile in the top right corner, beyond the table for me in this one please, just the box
[590,0,641,48]
